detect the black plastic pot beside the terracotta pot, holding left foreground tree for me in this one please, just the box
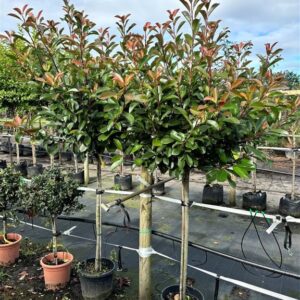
[79,258,115,300]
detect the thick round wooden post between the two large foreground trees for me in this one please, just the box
[139,168,152,300]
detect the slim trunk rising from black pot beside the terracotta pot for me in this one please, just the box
[95,155,102,272]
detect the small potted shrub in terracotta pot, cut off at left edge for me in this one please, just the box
[0,167,22,266]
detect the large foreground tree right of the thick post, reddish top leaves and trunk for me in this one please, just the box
[118,0,296,300]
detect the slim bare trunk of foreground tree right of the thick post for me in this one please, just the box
[180,169,190,300]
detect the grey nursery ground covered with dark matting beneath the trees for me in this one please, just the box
[1,152,300,300]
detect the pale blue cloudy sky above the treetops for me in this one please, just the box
[0,0,300,74]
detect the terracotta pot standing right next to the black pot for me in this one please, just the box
[40,252,74,291]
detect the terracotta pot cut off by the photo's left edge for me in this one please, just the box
[0,233,22,266]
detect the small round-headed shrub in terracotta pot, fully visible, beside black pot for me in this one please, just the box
[22,168,83,290]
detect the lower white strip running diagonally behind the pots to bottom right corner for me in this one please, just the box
[0,216,297,300]
